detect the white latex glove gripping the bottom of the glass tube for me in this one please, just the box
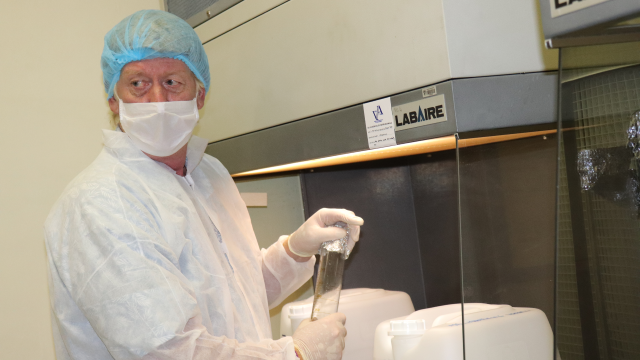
[293,313,347,360]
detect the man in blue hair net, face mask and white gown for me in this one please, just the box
[45,11,363,360]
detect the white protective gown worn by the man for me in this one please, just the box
[45,130,315,360]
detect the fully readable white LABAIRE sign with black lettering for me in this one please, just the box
[392,95,447,131]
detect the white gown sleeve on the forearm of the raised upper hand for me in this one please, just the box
[262,235,316,309]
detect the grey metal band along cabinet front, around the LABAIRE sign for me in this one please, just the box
[207,73,556,174]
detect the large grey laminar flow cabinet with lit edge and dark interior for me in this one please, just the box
[162,0,558,358]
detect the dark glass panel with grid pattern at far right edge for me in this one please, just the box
[556,43,640,360]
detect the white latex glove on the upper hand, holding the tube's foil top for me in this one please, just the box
[289,209,364,257]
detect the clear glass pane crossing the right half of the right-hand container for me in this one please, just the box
[458,131,557,360]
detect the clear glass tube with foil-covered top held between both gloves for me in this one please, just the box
[311,221,349,321]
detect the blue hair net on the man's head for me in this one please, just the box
[100,10,210,98]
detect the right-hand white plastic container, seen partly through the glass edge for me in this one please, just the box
[373,303,553,360]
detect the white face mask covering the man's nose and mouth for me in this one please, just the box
[120,99,200,156]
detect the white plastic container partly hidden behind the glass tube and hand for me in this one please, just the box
[280,289,415,360]
